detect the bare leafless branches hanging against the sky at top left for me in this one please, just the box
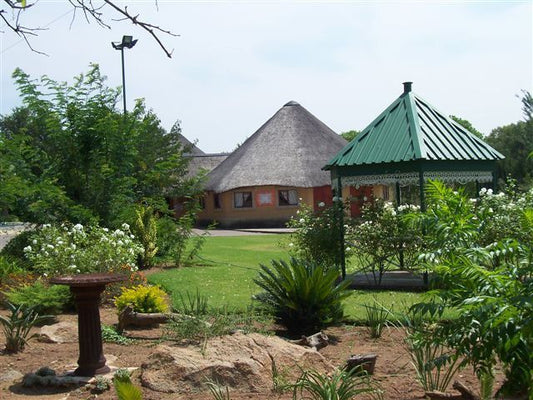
[0,0,177,57]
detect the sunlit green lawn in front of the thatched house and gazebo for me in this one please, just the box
[149,235,421,320]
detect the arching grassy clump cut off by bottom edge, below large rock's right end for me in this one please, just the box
[293,369,381,400]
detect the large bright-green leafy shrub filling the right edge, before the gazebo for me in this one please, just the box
[404,182,533,394]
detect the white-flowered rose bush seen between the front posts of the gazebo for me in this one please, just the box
[352,199,422,286]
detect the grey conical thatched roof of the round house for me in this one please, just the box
[206,101,347,193]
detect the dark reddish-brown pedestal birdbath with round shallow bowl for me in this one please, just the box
[50,273,126,376]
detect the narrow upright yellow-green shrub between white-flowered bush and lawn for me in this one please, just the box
[132,206,158,269]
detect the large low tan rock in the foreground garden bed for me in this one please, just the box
[141,332,334,394]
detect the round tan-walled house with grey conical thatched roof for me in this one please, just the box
[198,101,347,228]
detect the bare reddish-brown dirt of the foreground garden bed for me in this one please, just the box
[0,308,502,400]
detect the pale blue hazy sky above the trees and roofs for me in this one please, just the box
[0,0,533,153]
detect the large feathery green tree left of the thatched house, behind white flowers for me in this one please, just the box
[0,65,199,226]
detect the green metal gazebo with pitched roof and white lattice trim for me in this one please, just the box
[323,82,504,276]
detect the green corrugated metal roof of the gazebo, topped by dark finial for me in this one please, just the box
[324,82,503,169]
